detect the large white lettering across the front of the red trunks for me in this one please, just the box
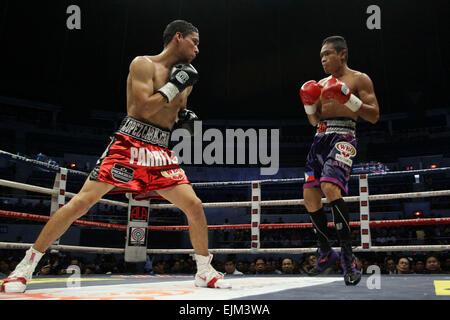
[130,147,178,167]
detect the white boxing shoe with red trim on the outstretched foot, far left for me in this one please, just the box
[1,247,43,293]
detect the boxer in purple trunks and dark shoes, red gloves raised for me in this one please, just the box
[300,36,379,285]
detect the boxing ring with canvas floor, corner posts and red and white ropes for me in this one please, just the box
[0,151,450,300]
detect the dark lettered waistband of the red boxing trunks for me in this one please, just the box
[117,116,170,148]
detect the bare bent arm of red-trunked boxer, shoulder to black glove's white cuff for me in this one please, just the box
[130,57,167,118]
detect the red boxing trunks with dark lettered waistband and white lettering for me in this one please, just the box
[89,116,189,200]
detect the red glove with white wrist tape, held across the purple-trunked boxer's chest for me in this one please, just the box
[322,77,363,112]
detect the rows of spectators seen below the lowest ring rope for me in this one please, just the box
[0,250,450,278]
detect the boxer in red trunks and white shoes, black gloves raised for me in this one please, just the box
[2,20,231,293]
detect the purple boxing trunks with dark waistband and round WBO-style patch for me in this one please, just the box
[303,118,357,195]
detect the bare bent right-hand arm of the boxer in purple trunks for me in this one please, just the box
[357,73,380,123]
